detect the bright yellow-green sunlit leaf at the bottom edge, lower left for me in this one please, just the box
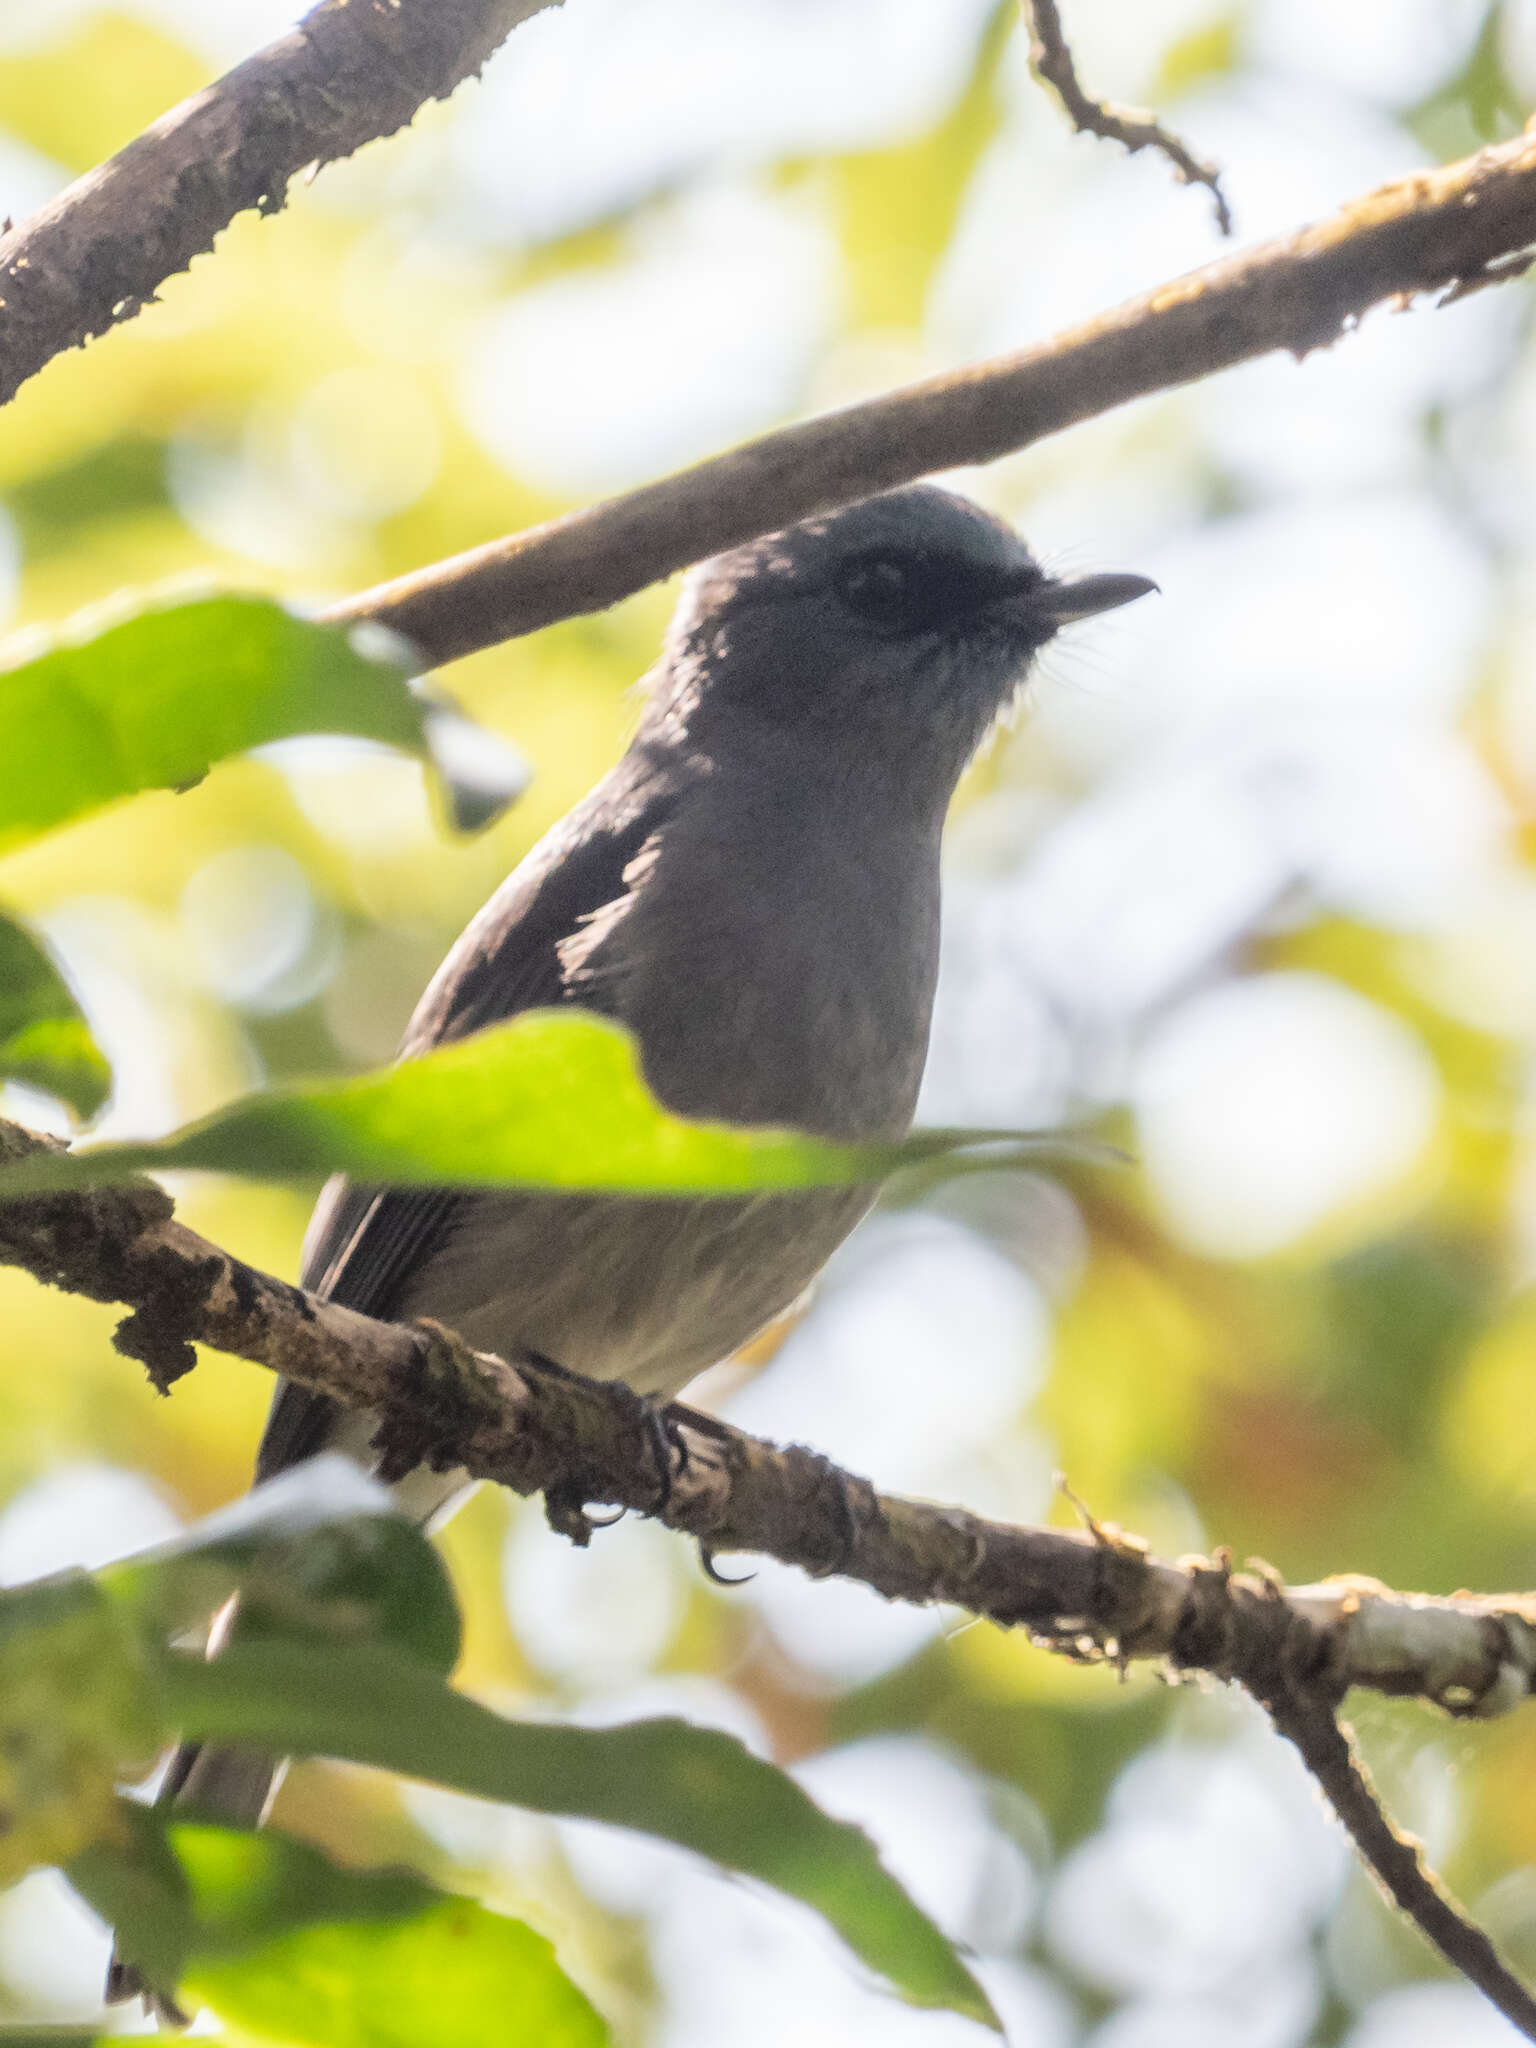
[70,1815,608,2048]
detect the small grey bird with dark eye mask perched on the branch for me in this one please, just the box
[115,485,1155,1991]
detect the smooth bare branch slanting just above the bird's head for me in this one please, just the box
[326,129,1536,662]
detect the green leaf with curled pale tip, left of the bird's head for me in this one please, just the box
[0,596,526,850]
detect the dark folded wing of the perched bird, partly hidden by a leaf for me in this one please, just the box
[256,772,672,1481]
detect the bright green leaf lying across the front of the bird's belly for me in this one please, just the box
[0,1010,1057,1200]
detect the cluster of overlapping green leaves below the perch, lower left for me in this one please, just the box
[0,1458,993,2044]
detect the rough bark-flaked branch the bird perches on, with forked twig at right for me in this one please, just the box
[0,1122,1536,2015]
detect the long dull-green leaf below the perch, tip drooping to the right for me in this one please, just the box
[164,1640,997,2025]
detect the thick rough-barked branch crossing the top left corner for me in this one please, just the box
[0,0,553,403]
